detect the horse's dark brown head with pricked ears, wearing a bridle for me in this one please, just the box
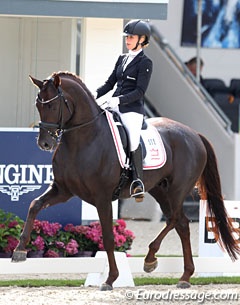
[29,73,72,150]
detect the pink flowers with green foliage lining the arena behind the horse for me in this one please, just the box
[0,209,135,257]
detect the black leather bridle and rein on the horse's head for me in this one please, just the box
[36,79,105,142]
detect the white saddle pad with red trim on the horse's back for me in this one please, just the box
[106,111,167,170]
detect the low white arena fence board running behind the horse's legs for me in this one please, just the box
[0,252,240,287]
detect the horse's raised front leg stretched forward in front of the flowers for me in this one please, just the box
[12,184,71,262]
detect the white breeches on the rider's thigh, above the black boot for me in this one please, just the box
[113,107,143,151]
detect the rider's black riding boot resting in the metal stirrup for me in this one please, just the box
[130,145,144,202]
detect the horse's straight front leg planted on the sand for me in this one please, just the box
[98,201,119,291]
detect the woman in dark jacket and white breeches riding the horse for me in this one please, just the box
[94,20,152,201]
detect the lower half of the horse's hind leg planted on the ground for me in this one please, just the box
[175,214,194,288]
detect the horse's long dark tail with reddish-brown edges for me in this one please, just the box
[198,134,240,260]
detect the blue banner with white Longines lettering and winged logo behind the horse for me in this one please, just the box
[0,128,81,225]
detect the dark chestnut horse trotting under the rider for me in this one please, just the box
[12,72,240,290]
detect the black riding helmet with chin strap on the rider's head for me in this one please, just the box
[123,20,151,48]
